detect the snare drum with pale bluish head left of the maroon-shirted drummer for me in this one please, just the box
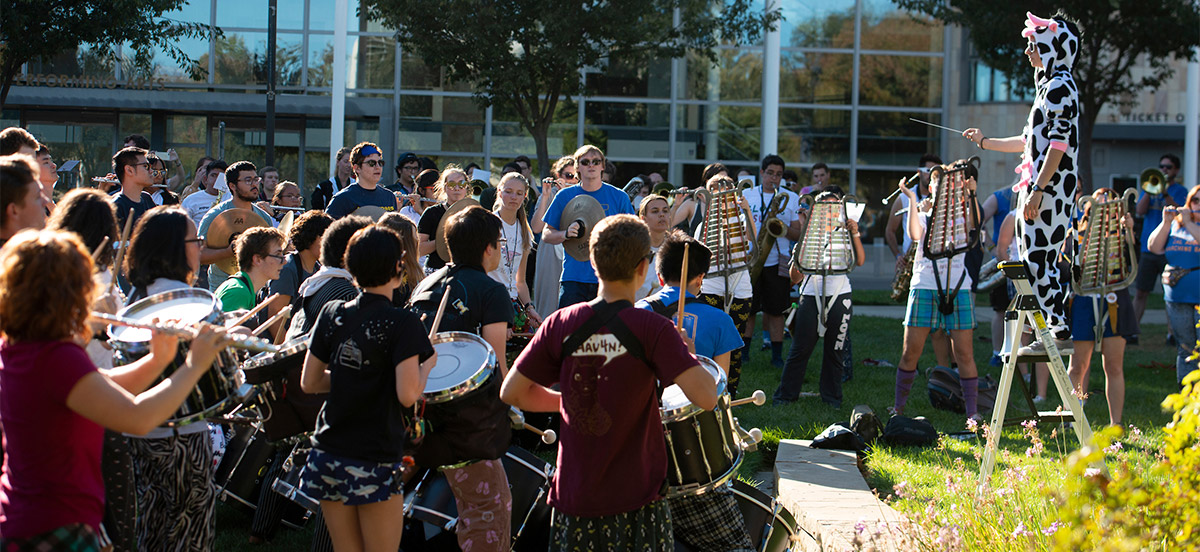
[425,331,496,404]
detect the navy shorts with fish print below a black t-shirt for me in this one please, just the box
[302,449,403,506]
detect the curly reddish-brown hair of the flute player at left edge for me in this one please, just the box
[0,230,96,342]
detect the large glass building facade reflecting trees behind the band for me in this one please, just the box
[2,0,949,241]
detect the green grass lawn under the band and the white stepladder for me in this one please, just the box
[215,312,1176,551]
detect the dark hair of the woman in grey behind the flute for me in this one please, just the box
[125,205,196,287]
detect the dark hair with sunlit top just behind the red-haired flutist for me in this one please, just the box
[46,188,120,266]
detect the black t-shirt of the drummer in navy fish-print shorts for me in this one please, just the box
[308,294,433,462]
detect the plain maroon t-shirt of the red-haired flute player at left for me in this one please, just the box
[0,341,104,539]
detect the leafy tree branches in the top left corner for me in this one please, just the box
[0,0,213,109]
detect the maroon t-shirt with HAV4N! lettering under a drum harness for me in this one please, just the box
[514,304,700,517]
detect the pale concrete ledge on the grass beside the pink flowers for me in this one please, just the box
[775,439,902,552]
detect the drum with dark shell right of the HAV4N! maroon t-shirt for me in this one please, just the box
[661,356,742,497]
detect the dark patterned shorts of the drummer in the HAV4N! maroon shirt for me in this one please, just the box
[550,500,674,552]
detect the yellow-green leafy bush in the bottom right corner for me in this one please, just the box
[1055,331,1200,551]
